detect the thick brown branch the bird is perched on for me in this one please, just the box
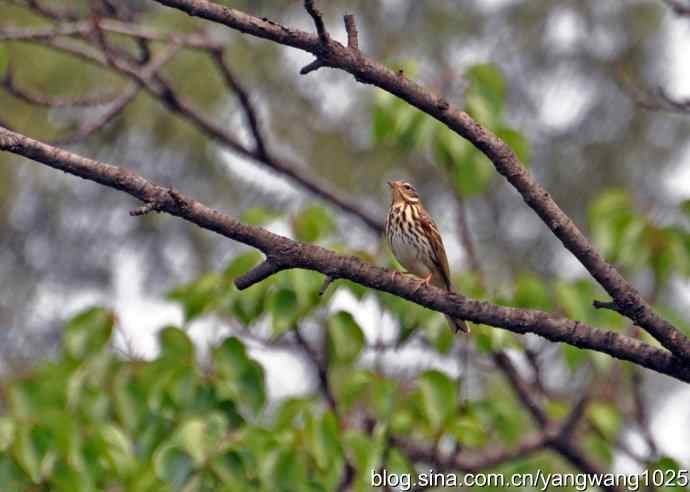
[0,124,690,382]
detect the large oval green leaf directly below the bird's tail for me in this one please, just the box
[418,370,458,433]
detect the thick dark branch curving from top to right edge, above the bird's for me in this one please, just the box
[149,0,690,360]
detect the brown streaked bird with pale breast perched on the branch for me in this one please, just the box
[385,181,470,334]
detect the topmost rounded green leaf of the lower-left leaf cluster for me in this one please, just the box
[63,308,115,359]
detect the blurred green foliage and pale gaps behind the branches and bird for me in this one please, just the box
[0,0,690,490]
